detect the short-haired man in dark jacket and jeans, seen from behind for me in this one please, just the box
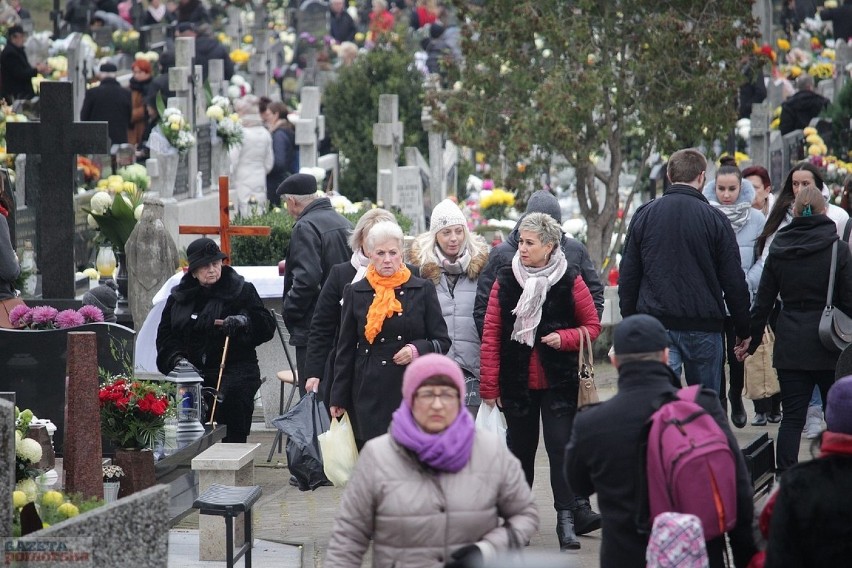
[618,149,751,393]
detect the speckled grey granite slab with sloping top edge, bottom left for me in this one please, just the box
[27,485,169,568]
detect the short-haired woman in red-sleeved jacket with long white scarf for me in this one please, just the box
[480,213,601,550]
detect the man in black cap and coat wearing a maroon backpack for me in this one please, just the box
[565,314,756,568]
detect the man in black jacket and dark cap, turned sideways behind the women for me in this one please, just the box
[277,174,352,395]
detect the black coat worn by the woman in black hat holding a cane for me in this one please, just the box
[157,266,275,387]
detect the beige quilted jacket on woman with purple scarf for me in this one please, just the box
[325,431,538,568]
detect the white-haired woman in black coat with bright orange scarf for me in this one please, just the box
[330,221,450,447]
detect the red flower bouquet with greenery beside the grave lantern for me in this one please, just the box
[98,375,176,450]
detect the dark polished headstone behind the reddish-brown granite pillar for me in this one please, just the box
[0,323,134,453]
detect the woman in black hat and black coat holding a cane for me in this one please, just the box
[157,238,275,443]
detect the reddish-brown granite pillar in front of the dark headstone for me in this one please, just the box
[62,331,104,498]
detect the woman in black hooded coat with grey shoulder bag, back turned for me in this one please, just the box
[737,185,852,472]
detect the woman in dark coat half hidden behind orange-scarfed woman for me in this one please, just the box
[303,208,396,400]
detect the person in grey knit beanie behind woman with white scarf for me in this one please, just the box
[473,189,604,337]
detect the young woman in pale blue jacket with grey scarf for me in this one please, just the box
[704,165,766,428]
